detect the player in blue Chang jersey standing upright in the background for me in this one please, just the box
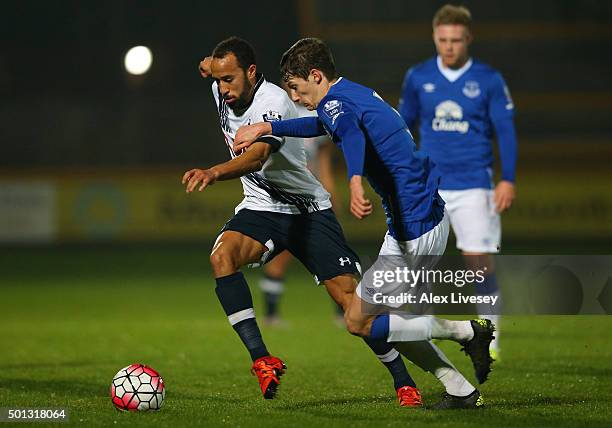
[398,5,517,359]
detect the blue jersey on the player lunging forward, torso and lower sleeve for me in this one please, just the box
[317,78,444,241]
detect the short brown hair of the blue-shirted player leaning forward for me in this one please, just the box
[280,37,337,81]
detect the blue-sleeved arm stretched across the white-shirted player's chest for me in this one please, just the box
[233,117,325,153]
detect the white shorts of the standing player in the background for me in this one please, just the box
[438,189,501,254]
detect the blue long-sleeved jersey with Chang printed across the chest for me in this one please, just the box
[399,58,516,190]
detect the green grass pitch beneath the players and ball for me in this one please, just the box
[0,245,612,428]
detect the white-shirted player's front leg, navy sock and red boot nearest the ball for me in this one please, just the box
[210,230,286,399]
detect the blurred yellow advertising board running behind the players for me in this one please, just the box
[0,170,612,242]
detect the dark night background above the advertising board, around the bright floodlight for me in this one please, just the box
[0,0,612,168]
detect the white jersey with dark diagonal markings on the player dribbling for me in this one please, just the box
[212,76,331,214]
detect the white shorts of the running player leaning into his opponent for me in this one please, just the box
[356,211,450,308]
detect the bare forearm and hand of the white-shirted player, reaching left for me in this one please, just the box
[183,142,272,193]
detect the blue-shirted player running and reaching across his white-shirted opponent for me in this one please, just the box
[233,38,494,409]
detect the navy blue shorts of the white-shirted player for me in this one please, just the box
[221,209,361,283]
